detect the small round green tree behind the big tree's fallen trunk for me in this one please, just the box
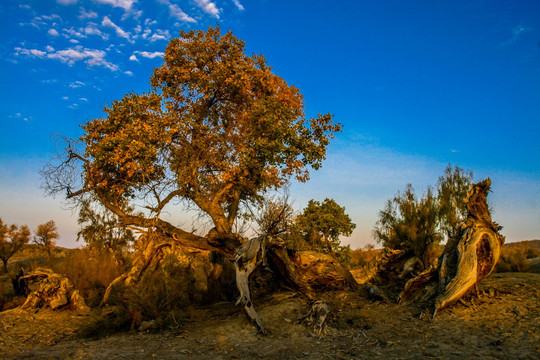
[296,199,356,253]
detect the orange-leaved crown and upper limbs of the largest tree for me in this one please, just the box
[42,27,341,256]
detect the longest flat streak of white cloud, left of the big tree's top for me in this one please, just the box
[15,45,120,71]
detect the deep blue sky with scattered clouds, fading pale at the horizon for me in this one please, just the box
[0,0,540,248]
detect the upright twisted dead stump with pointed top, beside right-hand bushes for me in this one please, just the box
[399,178,505,316]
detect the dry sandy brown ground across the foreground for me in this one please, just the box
[0,273,540,359]
